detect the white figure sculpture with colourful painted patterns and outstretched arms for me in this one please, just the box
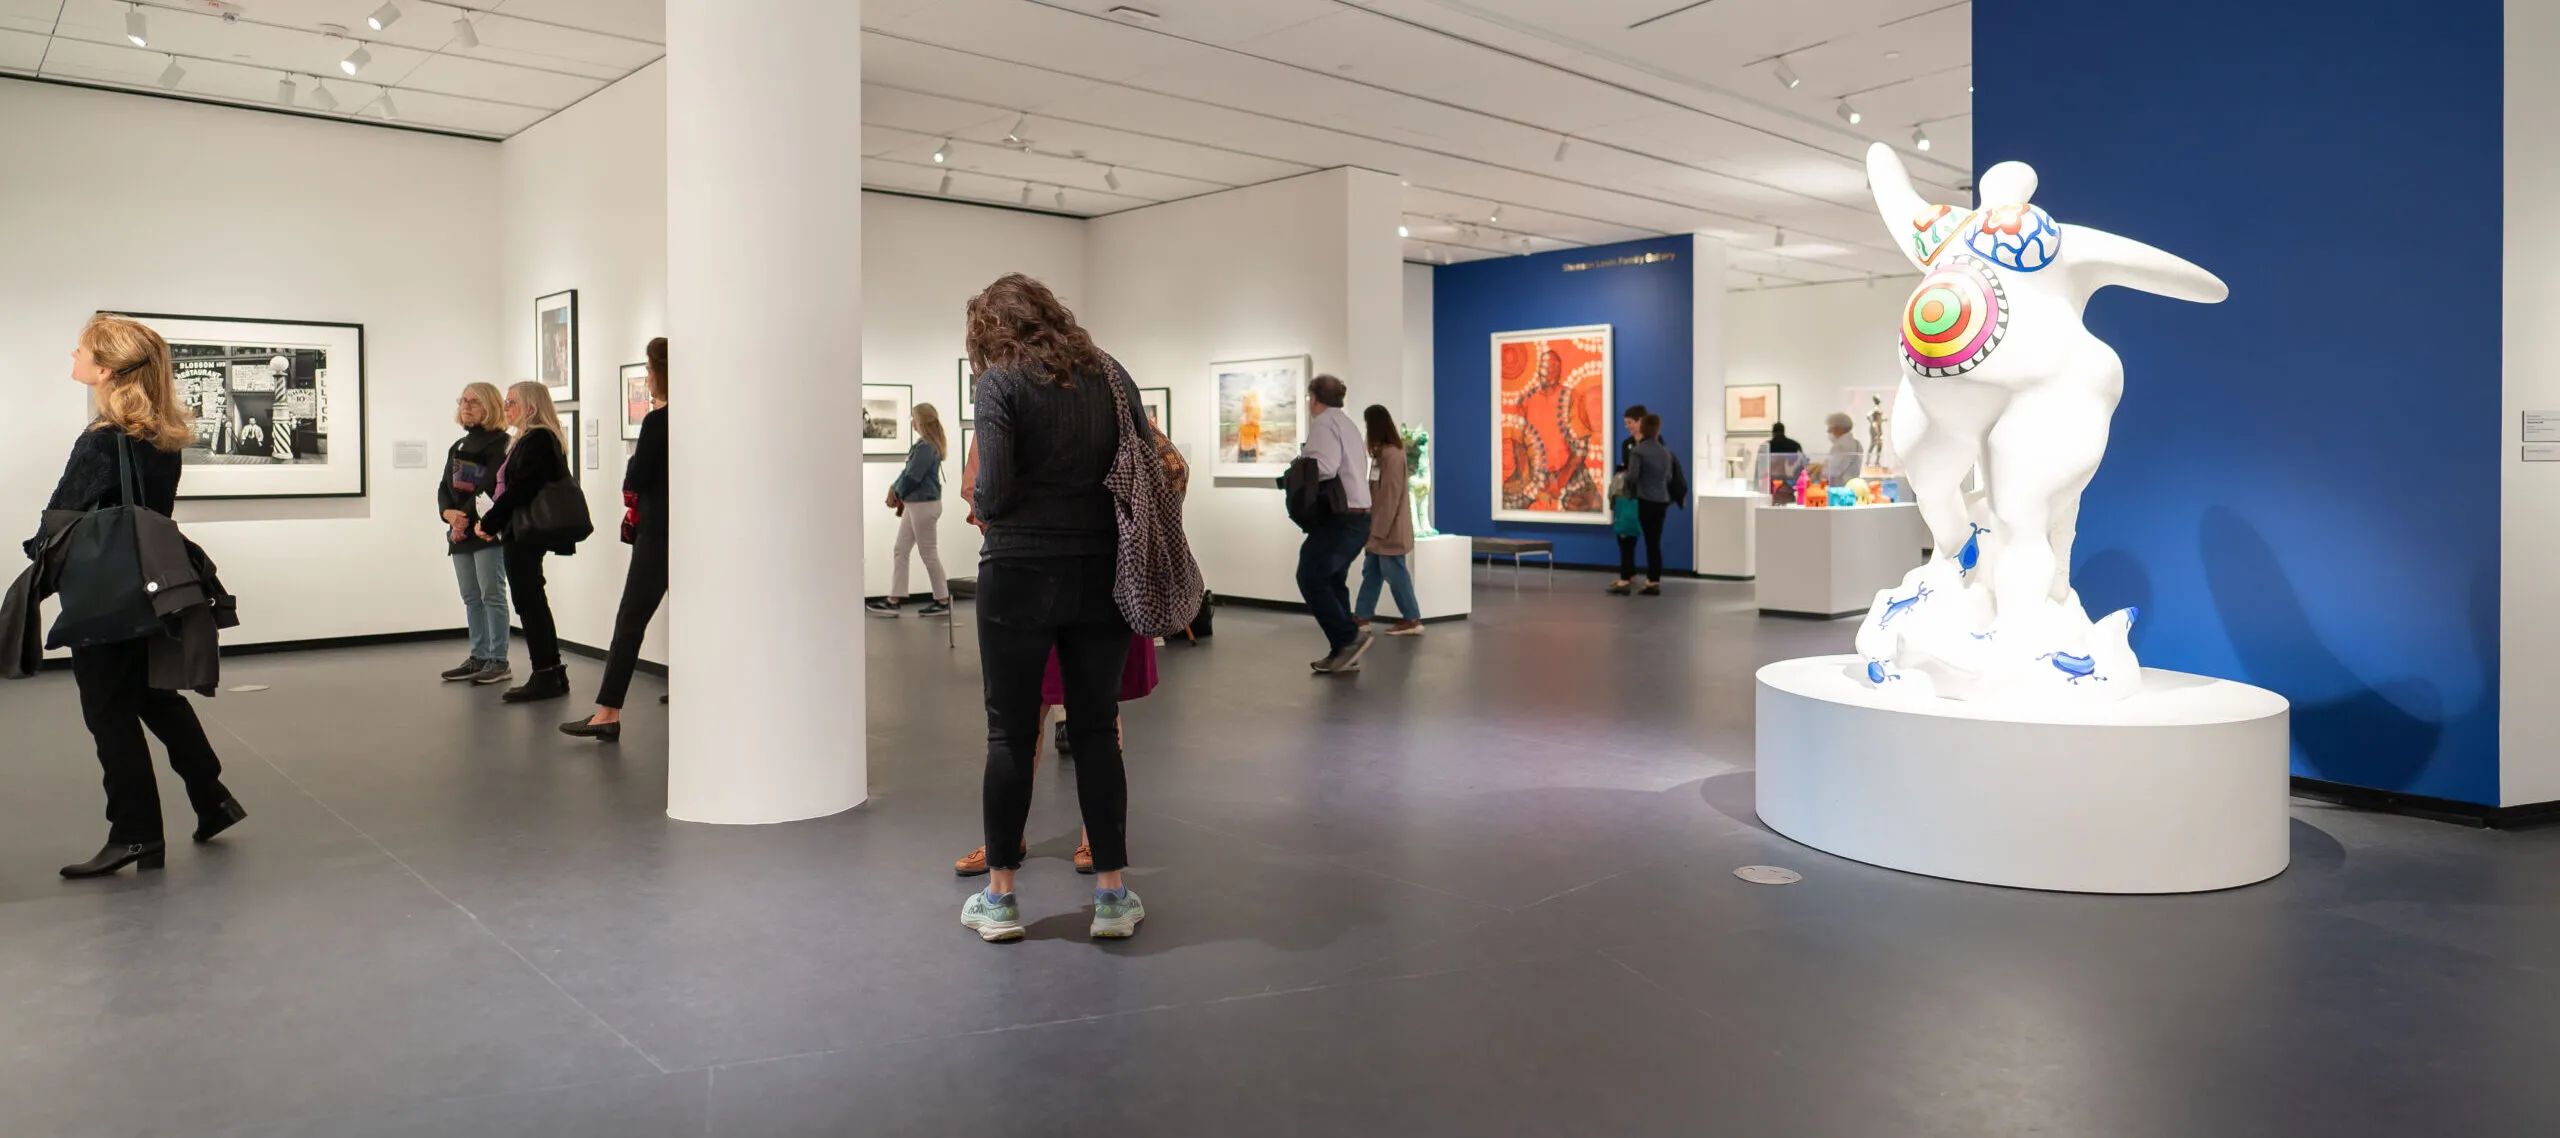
[1859,143,2230,701]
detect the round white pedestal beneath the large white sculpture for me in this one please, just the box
[1756,657,2291,892]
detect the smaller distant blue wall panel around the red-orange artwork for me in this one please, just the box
[1431,235,1723,570]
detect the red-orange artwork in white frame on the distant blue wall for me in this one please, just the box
[1492,325,1618,524]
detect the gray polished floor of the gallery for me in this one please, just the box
[0,573,2560,1138]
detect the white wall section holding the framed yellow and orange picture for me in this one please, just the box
[1078,169,1428,601]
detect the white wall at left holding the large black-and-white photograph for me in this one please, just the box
[0,82,499,644]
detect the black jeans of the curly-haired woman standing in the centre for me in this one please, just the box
[978,557,1129,872]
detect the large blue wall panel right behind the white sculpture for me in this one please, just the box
[1974,0,2514,806]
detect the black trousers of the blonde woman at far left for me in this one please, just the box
[72,639,230,846]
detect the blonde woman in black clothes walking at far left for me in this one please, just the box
[28,315,248,877]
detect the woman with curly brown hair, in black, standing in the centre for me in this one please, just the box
[960,274,1147,941]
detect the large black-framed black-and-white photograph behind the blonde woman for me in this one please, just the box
[123,312,366,499]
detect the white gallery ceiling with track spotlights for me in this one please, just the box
[0,0,1974,286]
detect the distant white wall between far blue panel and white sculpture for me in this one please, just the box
[1730,276,1920,450]
